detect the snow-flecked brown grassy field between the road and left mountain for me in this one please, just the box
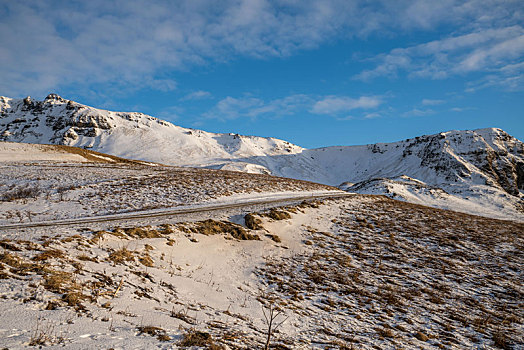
[0,143,337,225]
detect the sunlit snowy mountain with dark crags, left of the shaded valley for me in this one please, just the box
[0,94,303,172]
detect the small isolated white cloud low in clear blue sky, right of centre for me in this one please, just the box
[311,96,382,114]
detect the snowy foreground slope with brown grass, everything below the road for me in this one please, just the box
[0,195,524,349]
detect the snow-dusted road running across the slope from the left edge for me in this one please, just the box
[0,192,352,230]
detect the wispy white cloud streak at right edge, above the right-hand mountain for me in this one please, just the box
[355,25,524,89]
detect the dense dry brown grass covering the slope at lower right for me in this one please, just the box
[259,196,524,348]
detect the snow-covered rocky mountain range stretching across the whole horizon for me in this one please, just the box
[0,94,524,220]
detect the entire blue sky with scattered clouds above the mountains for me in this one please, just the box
[0,0,524,148]
